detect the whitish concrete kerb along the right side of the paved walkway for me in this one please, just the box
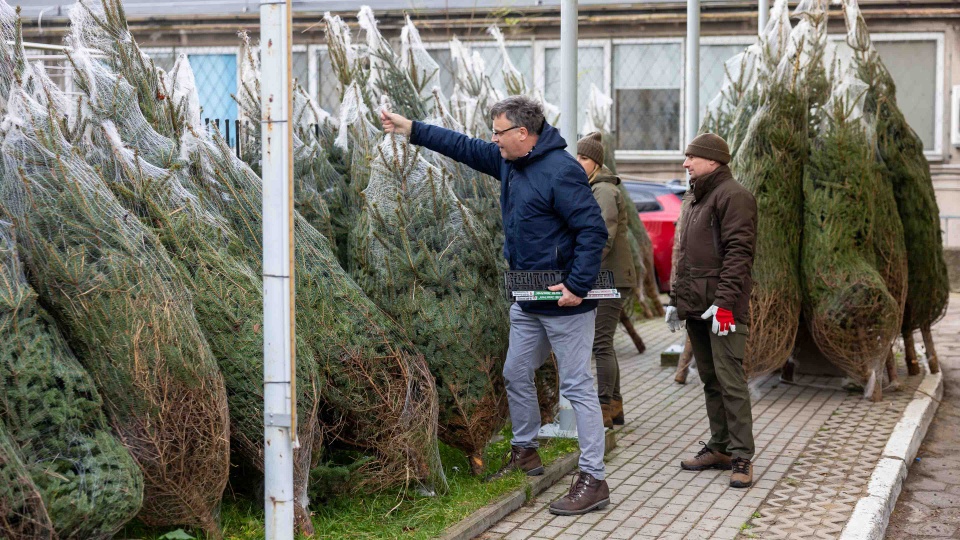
[840,373,943,540]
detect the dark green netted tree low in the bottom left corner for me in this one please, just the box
[0,222,143,539]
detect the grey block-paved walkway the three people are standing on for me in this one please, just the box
[480,297,960,540]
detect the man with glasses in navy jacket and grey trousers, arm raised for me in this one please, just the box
[381,96,610,515]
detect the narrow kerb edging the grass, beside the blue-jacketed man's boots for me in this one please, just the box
[440,452,580,540]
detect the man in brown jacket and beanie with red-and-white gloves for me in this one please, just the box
[666,133,757,488]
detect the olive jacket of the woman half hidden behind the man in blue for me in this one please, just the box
[590,167,637,288]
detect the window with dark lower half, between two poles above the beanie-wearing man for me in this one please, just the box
[613,41,683,152]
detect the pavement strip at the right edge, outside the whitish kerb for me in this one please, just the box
[887,294,960,540]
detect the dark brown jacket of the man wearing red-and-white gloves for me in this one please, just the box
[670,165,757,324]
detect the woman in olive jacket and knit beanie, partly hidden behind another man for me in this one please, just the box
[577,132,637,428]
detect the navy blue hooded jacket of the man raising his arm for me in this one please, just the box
[410,122,607,315]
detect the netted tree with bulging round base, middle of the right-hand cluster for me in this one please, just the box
[801,72,900,385]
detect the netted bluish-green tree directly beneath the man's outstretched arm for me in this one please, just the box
[352,135,509,474]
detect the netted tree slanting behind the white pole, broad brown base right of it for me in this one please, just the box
[188,126,444,490]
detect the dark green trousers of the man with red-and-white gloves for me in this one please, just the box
[687,318,755,460]
